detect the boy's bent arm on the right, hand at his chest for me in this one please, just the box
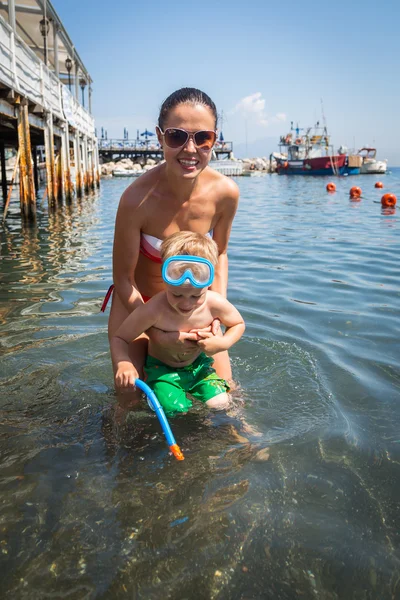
[197,292,246,355]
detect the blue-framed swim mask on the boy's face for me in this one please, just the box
[161,254,214,288]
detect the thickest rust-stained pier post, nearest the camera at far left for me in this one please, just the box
[18,101,36,219]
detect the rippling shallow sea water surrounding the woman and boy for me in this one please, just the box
[0,169,400,600]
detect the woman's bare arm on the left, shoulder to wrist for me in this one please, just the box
[113,186,143,312]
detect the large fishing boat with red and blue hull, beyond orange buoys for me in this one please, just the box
[271,121,354,175]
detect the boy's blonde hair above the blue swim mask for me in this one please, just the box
[161,231,219,267]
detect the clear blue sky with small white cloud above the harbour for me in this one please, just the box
[53,0,400,165]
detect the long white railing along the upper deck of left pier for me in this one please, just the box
[0,17,95,137]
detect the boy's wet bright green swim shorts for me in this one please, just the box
[144,352,229,415]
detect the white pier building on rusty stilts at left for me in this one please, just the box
[0,0,99,218]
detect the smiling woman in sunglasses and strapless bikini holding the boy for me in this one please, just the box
[104,88,239,404]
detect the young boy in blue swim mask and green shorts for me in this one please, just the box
[110,231,245,414]
